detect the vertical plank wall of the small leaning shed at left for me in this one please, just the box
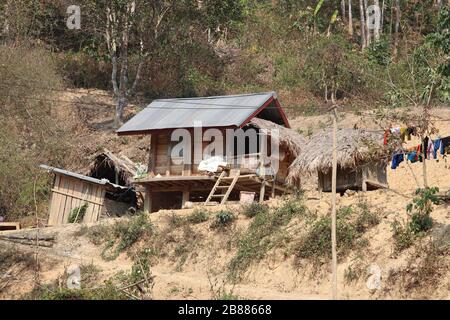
[48,174,106,226]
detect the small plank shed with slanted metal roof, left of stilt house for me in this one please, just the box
[40,165,123,226]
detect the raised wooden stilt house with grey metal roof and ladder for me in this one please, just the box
[117,92,305,212]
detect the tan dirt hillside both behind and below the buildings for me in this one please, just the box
[0,91,450,299]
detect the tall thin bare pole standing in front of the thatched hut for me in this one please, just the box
[331,105,337,300]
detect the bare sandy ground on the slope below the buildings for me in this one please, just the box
[3,190,450,299]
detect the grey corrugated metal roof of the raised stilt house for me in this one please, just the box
[117,92,276,134]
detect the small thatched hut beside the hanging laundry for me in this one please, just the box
[288,129,386,190]
